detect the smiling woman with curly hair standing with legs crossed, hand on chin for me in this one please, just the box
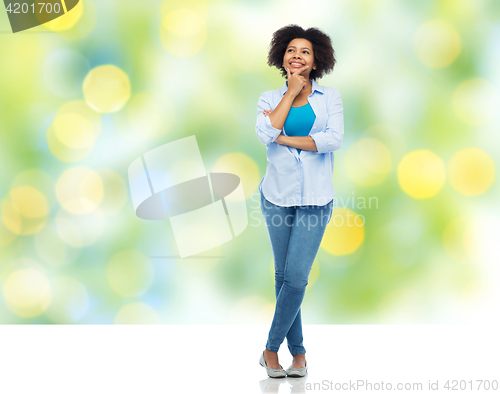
[256,25,344,377]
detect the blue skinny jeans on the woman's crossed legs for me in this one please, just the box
[260,192,333,356]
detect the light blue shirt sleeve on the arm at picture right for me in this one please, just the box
[311,90,344,154]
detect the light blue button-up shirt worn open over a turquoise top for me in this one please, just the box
[255,80,344,207]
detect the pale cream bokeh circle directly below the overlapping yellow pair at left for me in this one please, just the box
[56,166,104,215]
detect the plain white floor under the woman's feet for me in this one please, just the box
[0,325,500,394]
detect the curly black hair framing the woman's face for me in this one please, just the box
[267,25,337,80]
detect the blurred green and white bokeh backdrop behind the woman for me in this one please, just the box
[0,0,500,324]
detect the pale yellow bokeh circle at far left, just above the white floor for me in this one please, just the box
[3,268,51,318]
